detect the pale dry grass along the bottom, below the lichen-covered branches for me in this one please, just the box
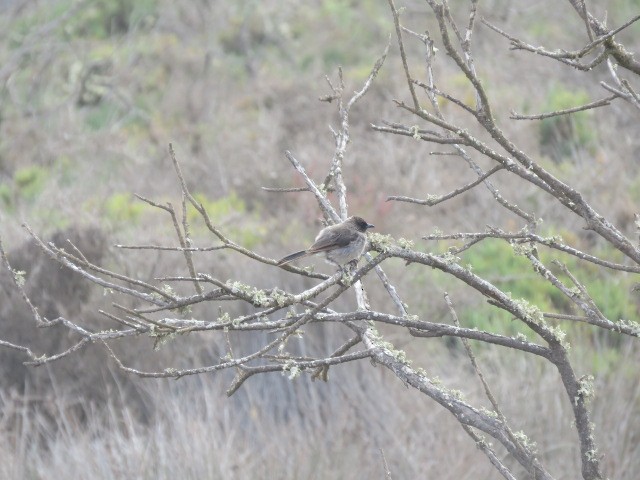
[0,340,640,480]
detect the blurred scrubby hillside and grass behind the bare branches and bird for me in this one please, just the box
[0,0,640,480]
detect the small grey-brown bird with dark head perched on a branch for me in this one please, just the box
[277,217,374,268]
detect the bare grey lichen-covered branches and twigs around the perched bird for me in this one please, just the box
[0,0,640,480]
